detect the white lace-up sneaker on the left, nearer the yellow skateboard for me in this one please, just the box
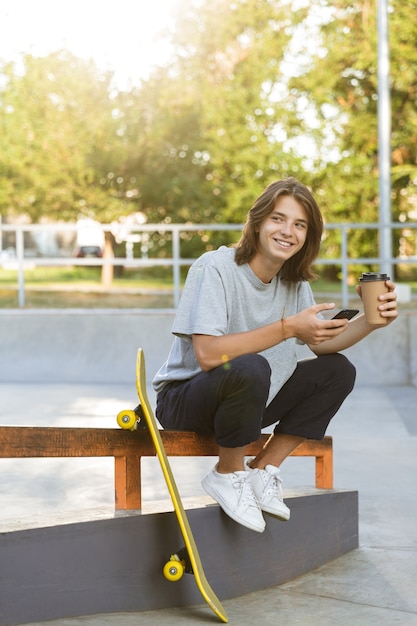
[201,465,265,533]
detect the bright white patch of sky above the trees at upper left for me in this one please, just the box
[0,0,176,85]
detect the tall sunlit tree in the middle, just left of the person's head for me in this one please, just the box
[122,0,308,229]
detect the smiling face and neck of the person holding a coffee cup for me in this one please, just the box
[249,196,308,283]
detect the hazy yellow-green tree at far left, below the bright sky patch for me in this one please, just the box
[0,51,128,220]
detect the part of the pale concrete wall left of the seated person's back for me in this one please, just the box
[0,309,175,384]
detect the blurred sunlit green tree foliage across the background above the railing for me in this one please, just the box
[0,0,417,272]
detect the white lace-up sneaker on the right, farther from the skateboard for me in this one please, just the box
[245,459,290,521]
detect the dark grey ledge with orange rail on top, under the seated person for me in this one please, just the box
[0,342,358,626]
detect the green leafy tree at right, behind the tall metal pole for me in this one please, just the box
[282,0,417,276]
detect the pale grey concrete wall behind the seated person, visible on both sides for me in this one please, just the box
[0,309,417,385]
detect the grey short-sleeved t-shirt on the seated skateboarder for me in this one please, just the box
[153,246,315,402]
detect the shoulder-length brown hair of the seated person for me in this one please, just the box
[235,177,323,282]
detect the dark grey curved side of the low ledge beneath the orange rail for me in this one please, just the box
[0,490,358,626]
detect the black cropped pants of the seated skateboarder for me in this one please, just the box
[156,354,356,448]
